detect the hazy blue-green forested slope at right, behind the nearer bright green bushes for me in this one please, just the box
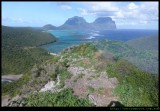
[95,37,158,74]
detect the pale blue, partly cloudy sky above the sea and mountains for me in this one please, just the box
[1,1,159,30]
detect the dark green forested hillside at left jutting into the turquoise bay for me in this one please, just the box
[2,26,56,74]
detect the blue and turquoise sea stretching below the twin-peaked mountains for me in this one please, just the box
[42,29,158,53]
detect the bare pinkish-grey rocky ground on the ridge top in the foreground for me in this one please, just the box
[65,65,118,106]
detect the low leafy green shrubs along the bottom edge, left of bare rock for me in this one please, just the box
[25,89,93,107]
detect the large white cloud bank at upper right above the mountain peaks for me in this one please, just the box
[78,2,158,25]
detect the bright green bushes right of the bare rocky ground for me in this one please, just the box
[107,60,159,106]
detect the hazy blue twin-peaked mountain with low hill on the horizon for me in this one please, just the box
[42,16,116,30]
